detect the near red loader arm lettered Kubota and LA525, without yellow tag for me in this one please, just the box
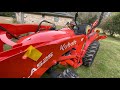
[0,35,85,78]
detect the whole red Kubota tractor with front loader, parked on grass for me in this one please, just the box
[0,13,106,78]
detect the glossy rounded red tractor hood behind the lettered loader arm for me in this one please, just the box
[17,28,74,46]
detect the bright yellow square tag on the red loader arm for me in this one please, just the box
[23,45,42,61]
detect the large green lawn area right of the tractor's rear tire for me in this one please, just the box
[75,37,120,78]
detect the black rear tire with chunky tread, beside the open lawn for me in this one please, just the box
[83,41,100,67]
